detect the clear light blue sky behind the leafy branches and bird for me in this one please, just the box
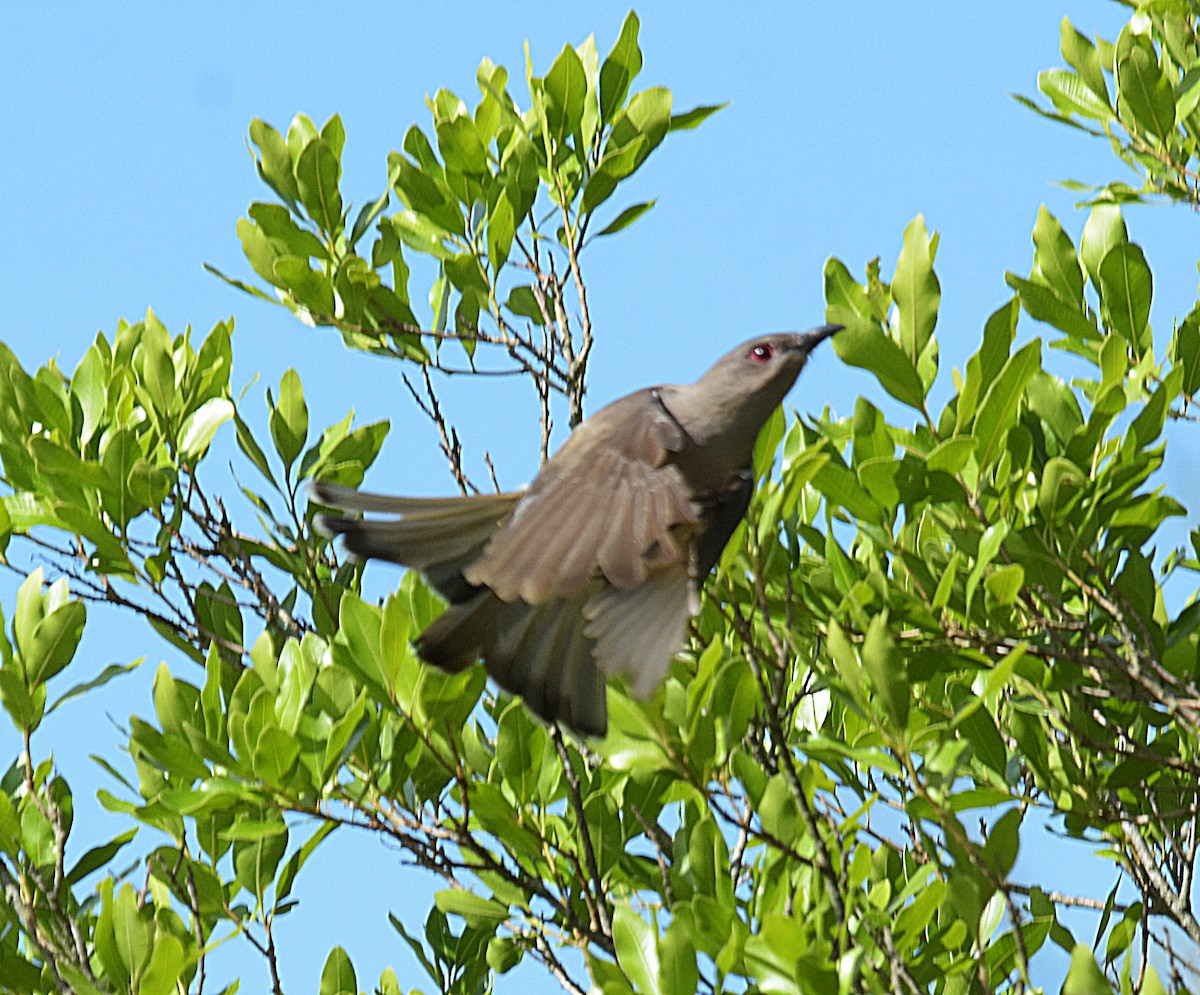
[0,0,1200,991]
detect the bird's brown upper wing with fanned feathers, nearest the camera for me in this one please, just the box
[464,390,700,604]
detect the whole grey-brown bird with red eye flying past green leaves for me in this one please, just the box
[312,325,841,736]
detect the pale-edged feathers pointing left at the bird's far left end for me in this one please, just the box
[312,482,522,601]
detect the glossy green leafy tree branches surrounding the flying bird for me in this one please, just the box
[0,4,1200,995]
